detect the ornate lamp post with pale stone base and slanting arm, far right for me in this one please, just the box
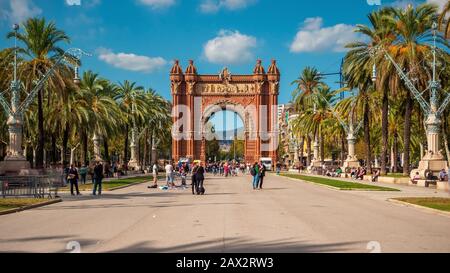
[372,23,450,187]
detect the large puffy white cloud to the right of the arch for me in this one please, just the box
[290,17,358,53]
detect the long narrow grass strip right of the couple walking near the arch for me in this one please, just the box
[282,174,399,191]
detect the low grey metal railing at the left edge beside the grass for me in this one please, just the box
[0,174,64,198]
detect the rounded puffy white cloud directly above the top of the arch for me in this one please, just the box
[204,30,257,64]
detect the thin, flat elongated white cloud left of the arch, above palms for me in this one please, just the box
[97,48,167,73]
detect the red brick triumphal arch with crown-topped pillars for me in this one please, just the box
[170,60,280,164]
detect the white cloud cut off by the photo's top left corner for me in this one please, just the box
[0,0,42,23]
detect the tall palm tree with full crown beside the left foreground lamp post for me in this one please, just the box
[8,18,70,168]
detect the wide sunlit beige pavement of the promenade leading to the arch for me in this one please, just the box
[0,175,450,253]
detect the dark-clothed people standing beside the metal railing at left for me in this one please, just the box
[63,162,104,196]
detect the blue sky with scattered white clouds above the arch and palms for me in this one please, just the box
[0,0,444,103]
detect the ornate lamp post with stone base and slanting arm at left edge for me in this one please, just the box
[0,24,88,173]
